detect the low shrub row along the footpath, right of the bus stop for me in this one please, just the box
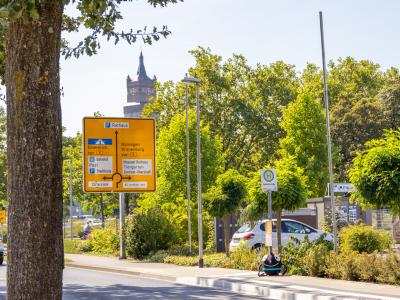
[283,232,400,284]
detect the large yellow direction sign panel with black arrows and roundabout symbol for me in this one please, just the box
[83,117,156,192]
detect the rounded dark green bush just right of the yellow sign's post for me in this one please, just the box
[126,208,176,259]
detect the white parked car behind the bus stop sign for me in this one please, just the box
[229,219,333,251]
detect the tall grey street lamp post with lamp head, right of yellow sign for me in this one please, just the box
[182,76,204,268]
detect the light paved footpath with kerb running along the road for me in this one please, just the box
[65,254,400,300]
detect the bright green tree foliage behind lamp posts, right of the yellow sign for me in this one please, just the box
[138,110,221,241]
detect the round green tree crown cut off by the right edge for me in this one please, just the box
[349,131,400,214]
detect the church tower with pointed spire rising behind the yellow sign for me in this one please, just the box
[124,51,156,118]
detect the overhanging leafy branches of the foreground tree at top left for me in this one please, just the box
[0,0,183,84]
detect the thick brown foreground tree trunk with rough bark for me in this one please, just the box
[6,0,64,300]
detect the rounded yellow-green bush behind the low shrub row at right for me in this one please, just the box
[339,225,393,253]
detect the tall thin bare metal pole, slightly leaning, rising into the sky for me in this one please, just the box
[319,11,338,253]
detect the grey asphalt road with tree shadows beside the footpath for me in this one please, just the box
[0,265,265,300]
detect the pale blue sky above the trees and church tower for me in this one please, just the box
[61,0,400,135]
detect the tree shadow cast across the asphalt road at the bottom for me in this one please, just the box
[63,284,259,300]
